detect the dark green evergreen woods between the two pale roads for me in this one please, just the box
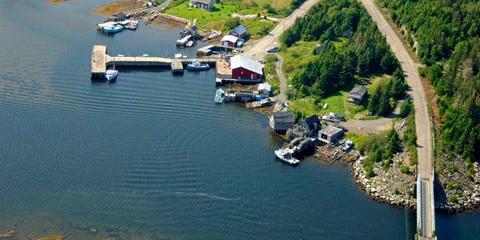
[281,0,406,115]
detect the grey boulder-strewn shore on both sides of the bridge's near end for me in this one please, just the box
[317,146,480,214]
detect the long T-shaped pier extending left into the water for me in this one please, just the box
[91,45,220,80]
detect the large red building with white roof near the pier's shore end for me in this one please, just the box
[230,55,263,80]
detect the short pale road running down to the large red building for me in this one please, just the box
[244,0,319,59]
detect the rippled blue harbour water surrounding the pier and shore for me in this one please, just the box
[0,0,480,239]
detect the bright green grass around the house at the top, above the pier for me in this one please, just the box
[163,1,276,36]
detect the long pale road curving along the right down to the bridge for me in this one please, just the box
[361,0,433,237]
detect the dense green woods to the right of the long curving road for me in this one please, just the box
[381,0,480,163]
